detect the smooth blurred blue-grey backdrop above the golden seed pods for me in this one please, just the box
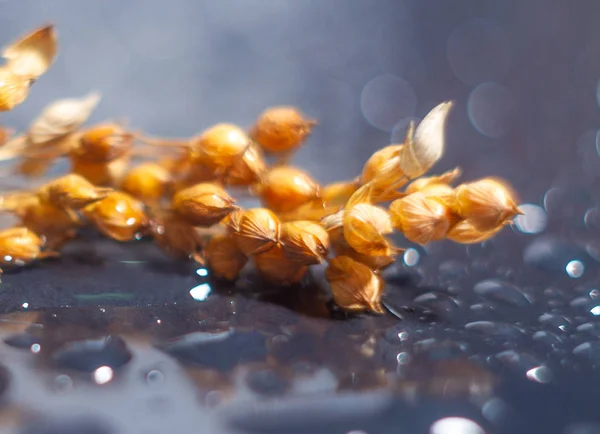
[0,0,600,205]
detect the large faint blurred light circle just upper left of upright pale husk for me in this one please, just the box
[360,74,417,131]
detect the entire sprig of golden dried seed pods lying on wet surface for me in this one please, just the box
[0,27,519,312]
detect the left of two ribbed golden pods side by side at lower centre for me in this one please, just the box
[233,208,281,256]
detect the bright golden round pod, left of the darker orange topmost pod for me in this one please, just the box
[191,123,251,171]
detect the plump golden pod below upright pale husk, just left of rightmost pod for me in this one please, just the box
[390,192,457,245]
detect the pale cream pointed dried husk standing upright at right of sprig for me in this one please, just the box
[399,101,453,179]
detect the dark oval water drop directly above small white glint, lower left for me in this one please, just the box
[51,336,132,373]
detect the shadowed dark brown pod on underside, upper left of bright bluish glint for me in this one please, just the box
[152,212,202,259]
